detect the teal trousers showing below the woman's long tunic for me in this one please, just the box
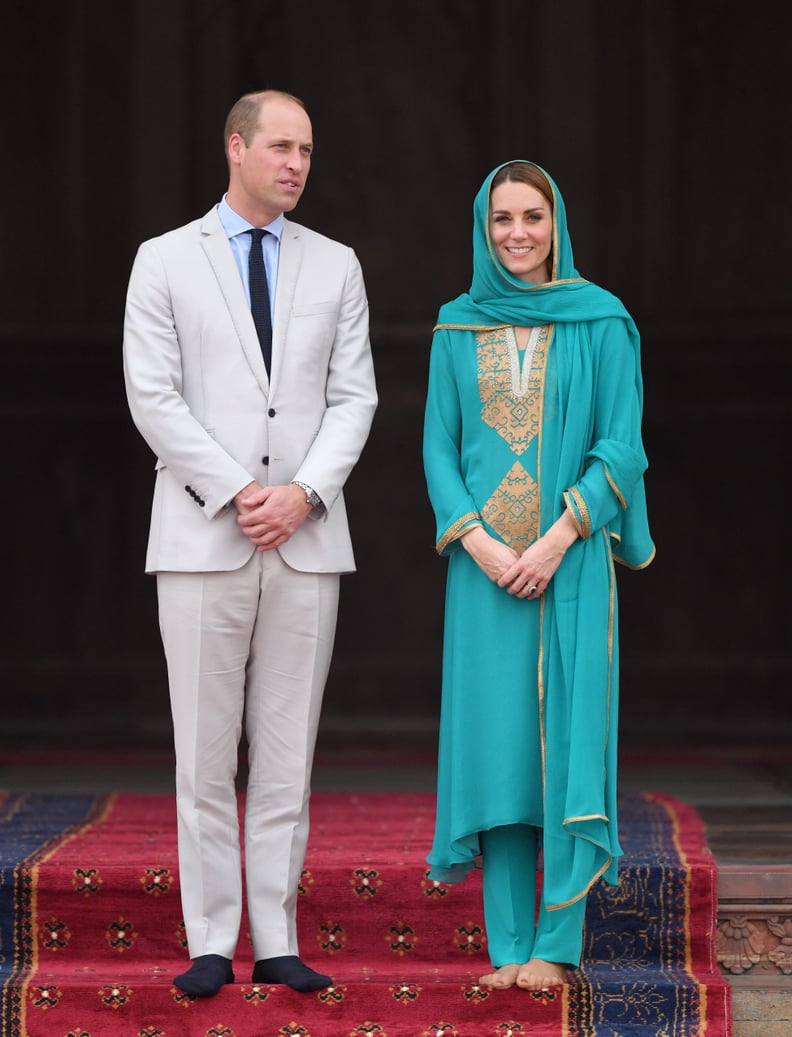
[479,824,586,969]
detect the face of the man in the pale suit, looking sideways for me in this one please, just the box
[229,97,313,223]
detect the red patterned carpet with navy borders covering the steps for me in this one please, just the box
[0,792,731,1037]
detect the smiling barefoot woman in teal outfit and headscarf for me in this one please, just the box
[424,161,654,990]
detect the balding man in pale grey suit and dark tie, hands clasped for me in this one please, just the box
[123,90,376,997]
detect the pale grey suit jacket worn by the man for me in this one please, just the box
[123,208,376,572]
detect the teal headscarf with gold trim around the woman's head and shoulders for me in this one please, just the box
[437,159,634,328]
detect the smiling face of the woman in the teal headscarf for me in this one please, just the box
[489,180,553,284]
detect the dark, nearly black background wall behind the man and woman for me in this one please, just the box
[0,0,792,744]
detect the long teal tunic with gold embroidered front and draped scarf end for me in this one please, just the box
[424,315,654,908]
